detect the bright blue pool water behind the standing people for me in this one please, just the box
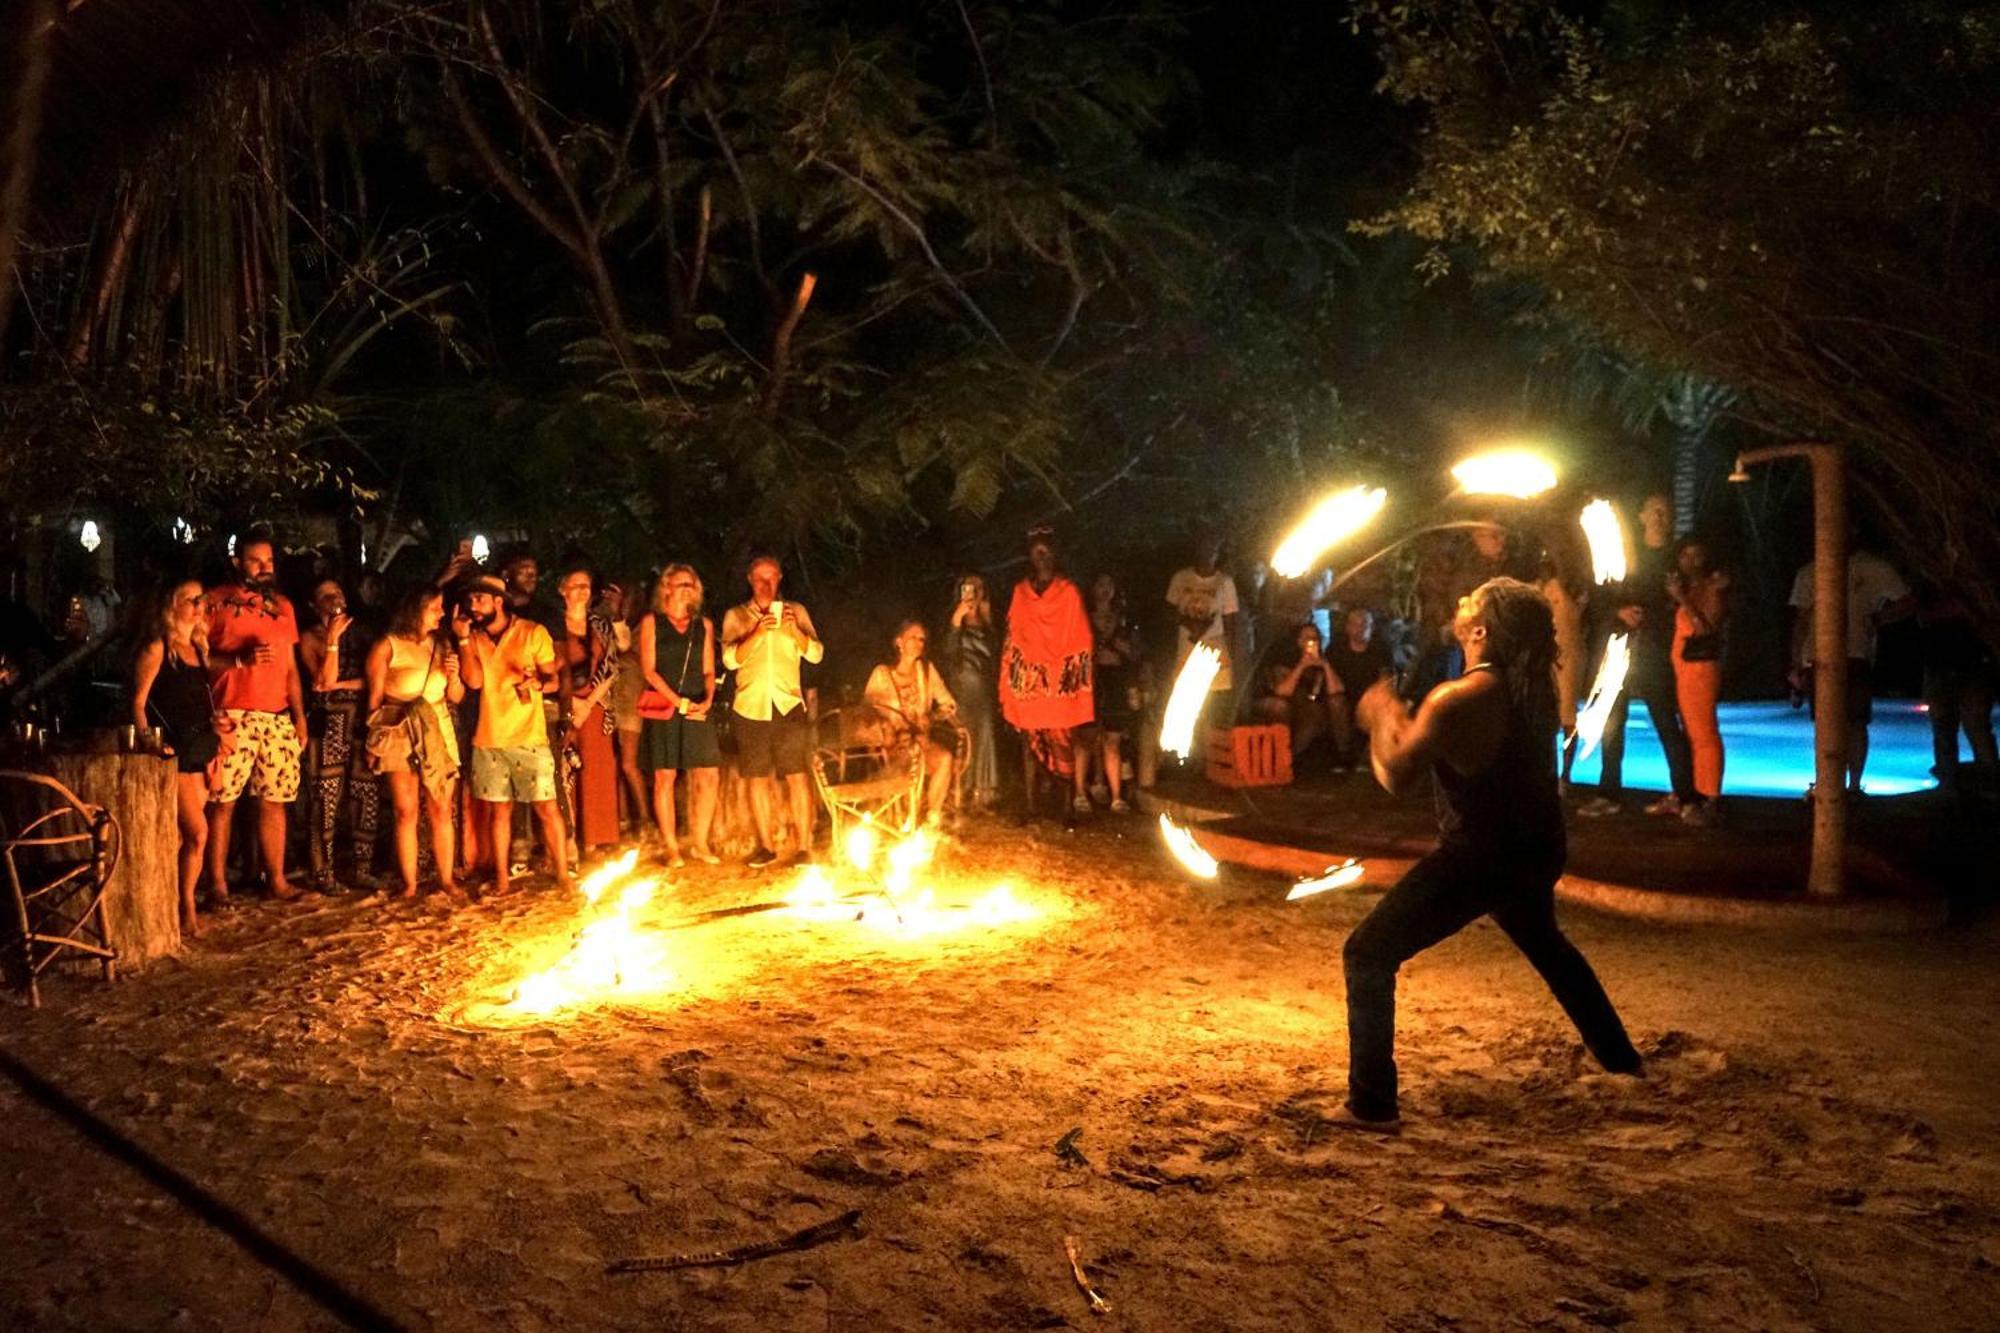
[1570,699,1972,797]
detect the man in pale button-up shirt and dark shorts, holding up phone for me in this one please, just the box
[722,556,826,867]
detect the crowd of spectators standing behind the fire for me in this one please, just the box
[0,494,1994,929]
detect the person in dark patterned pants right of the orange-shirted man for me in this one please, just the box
[298,578,382,893]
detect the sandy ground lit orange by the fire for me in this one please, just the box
[0,823,2000,1329]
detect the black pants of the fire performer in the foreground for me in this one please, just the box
[1344,843,1638,1119]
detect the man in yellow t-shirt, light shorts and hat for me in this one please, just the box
[458,574,570,895]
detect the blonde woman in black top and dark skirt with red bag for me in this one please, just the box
[636,564,722,869]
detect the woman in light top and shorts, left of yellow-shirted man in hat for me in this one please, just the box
[368,584,466,901]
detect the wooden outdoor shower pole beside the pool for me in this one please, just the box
[1730,442,1848,897]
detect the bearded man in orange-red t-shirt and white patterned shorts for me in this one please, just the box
[208,536,306,903]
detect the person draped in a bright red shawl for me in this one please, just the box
[1000,528,1096,817]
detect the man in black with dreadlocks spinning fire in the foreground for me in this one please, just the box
[1340,578,1640,1133]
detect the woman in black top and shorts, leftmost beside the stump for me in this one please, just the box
[132,578,222,937]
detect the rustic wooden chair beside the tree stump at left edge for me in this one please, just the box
[0,769,120,1007]
